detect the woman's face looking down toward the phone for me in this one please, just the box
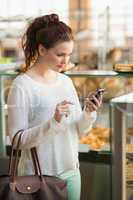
[38,41,74,72]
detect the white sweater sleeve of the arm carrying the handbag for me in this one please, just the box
[7,81,64,149]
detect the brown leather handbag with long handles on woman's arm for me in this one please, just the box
[0,130,68,200]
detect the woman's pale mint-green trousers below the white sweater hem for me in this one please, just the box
[59,169,81,200]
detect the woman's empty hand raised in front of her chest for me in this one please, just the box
[54,100,73,122]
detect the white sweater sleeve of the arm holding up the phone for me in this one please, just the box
[66,79,97,137]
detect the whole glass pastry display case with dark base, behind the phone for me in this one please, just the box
[67,70,133,200]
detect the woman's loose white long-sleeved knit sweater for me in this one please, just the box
[8,73,96,175]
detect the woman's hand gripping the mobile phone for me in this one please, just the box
[84,93,103,112]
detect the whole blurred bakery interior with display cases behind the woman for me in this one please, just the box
[0,0,133,200]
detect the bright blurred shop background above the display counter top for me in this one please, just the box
[0,0,133,70]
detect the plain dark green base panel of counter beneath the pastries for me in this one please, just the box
[79,149,112,200]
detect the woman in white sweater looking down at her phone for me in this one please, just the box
[8,14,101,200]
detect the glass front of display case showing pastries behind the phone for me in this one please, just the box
[70,76,133,155]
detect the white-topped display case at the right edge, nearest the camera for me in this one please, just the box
[110,93,133,200]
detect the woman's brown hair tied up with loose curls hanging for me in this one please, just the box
[20,14,73,72]
